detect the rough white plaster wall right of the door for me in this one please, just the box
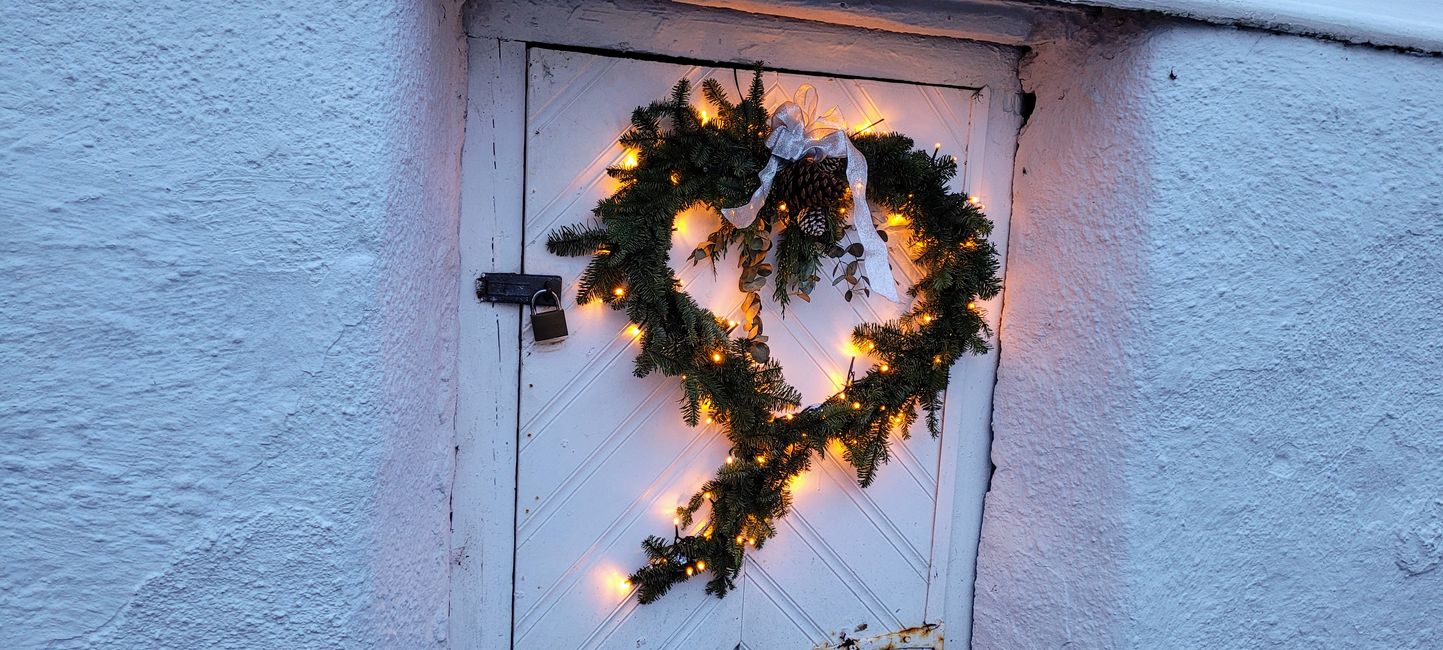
[974,15,1443,649]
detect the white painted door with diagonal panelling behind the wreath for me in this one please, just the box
[514,48,1004,650]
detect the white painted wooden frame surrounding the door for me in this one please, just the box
[449,0,1022,649]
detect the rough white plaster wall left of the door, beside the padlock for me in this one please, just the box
[0,0,465,649]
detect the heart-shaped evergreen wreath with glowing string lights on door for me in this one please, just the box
[547,66,1001,602]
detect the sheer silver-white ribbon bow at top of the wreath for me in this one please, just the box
[722,84,898,302]
